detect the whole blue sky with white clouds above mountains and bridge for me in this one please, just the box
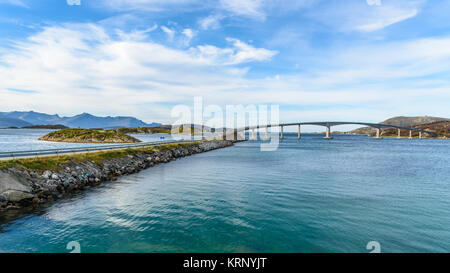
[0,0,450,129]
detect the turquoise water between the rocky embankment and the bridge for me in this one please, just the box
[0,134,450,252]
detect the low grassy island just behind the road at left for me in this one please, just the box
[39,129,141,143]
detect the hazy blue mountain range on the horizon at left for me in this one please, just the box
[0,111,161,129]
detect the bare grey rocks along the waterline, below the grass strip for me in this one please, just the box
[0,140,233,211]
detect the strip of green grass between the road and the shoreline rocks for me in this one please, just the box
[0,142,201,173]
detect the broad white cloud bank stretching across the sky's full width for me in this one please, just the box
[0,24,450,122]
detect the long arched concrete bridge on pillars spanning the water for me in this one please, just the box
[227,121,436,140]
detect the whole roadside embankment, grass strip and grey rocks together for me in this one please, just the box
[0,140,234,212]
